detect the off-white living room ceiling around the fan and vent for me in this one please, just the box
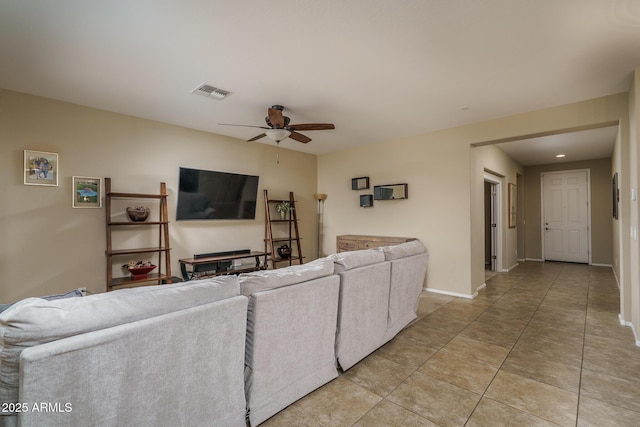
[0,0,640,163]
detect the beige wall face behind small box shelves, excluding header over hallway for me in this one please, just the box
[318,133,470,294]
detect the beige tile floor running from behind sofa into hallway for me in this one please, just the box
[262,262,640,427]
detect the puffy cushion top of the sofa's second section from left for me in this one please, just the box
[239,258,333,296]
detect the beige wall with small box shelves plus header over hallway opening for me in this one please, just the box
[318,93,629,296]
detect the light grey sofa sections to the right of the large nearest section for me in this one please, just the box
[240,240,429,426]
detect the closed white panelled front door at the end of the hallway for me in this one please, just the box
[542,170,589,263]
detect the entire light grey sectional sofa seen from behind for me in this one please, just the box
[0,241,428,426]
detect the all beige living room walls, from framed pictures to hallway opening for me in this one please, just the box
[5,83,640,338]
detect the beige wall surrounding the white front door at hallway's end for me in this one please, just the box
[524,159,613,265]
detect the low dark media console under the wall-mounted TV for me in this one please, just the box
[178,249,268,281]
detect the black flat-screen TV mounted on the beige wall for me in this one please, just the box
[176,168,258,220]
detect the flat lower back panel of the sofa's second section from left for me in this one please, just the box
[245,276,340,426]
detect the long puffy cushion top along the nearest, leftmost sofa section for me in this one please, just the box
[0,276,240,410]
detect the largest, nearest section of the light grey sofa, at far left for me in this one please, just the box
[0,276,248,427]
